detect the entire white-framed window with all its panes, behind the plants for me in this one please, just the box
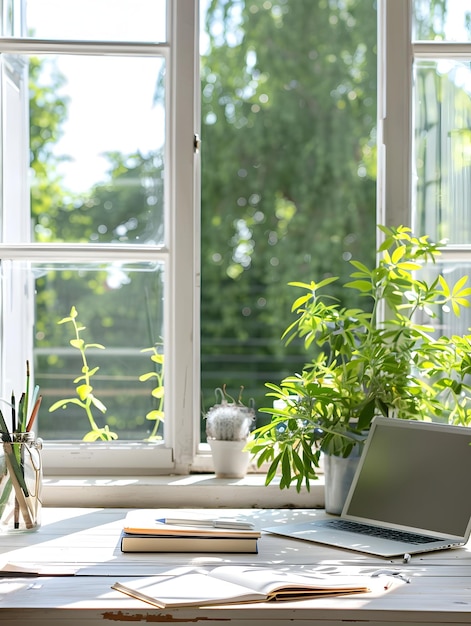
[0,0,471,482]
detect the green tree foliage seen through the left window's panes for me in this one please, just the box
[29,58,163,439]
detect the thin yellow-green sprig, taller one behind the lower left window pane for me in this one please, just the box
[49,306,118,441]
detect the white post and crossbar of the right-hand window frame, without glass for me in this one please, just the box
[377,0,471,241]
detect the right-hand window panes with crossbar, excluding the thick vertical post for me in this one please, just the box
[412,0,471,342]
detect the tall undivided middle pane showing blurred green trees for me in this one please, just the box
[201,0,377,428]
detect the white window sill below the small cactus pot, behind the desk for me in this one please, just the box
[43,474,324,509]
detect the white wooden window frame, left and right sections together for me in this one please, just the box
[0,0,471,492]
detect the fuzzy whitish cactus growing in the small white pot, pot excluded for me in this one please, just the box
[205,385,255,441]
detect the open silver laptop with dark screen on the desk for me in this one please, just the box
[263,417,471,557]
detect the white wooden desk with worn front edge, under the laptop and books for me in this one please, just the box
[0,508,471,626]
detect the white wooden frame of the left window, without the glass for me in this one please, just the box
[0,0,199,475]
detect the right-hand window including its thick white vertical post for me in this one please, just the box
[378,0,471,334]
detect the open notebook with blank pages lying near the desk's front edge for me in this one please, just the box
[112,565,376,608]
